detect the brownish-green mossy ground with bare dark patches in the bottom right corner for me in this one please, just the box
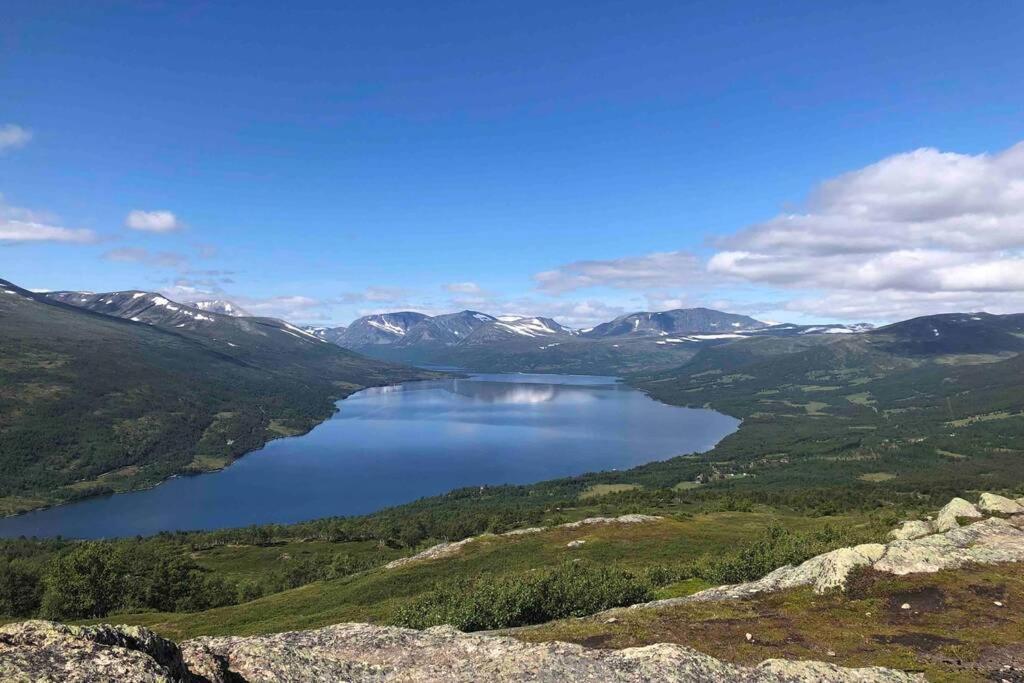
[509,564,1024,681]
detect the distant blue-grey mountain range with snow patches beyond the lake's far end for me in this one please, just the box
[306,308,871,374]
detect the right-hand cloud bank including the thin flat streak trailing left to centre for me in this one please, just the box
[535,142,1024,319]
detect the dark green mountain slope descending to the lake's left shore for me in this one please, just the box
[0,281,436,513]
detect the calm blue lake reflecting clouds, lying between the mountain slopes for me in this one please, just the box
[0,375,738,539]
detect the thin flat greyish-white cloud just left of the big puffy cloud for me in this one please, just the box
[534,251,708,294]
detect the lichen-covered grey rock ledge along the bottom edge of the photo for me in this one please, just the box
[0,622,924,683]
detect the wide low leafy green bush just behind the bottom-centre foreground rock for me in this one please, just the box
[395,562,651,631]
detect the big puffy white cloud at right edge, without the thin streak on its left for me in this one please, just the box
[708,143,1024,293]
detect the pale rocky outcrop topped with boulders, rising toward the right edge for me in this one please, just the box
[630,497,1024,612]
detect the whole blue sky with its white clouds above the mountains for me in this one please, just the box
[0,0,1024,326]
